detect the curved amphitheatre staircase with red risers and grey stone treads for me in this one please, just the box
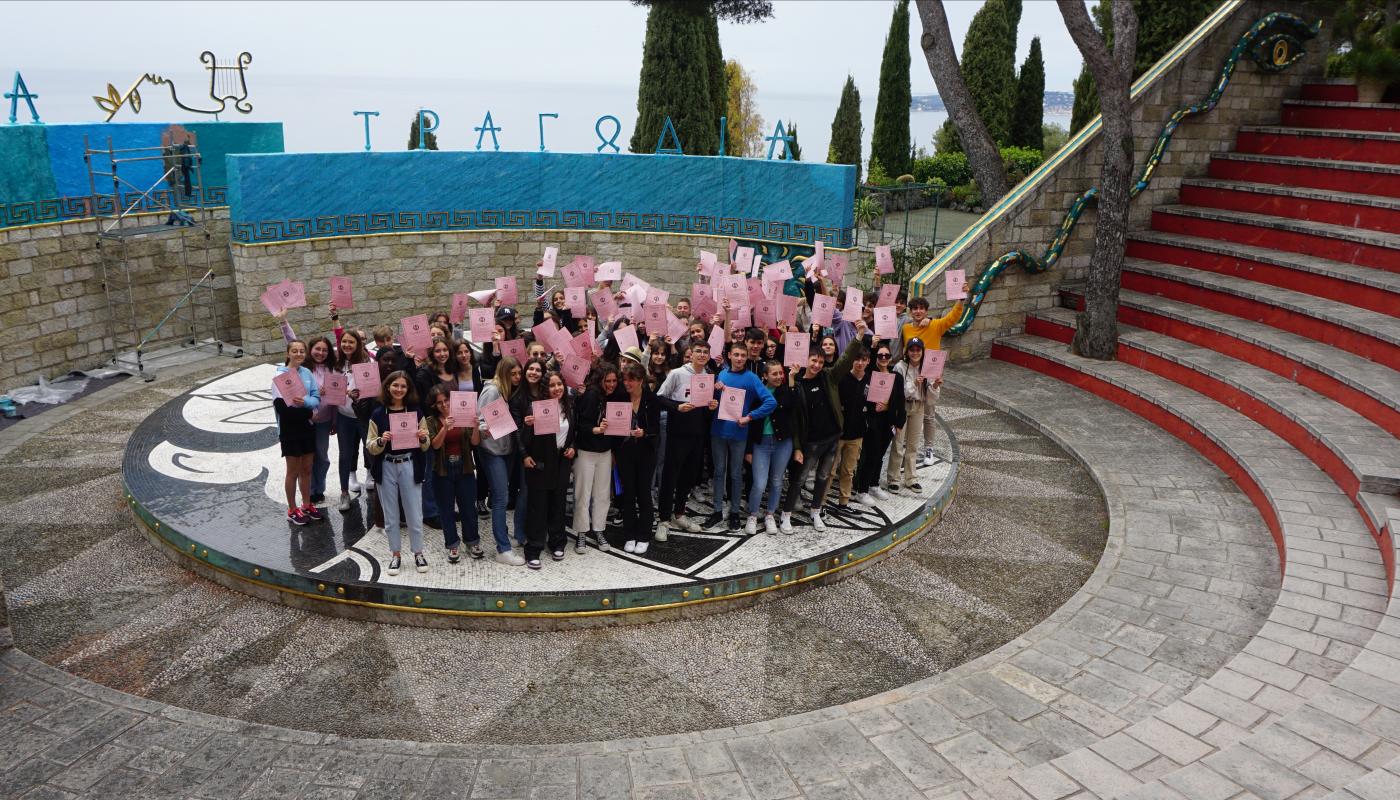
[991,84,1400,800]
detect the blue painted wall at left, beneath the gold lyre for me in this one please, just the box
[0,122,283,228]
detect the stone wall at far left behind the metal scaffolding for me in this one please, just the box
[0,210,238,391]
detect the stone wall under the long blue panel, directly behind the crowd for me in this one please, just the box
[232,231,729,354]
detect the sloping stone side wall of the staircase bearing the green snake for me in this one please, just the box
[925,0,1330,360]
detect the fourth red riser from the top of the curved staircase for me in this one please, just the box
[1210,153,1400,198]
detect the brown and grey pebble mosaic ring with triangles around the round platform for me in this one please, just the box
[0,360,1106,744]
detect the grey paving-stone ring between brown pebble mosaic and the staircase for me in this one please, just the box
[0,363,1299,800]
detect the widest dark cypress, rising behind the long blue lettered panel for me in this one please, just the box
[629,3,728,156]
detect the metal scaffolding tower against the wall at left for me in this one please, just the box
[83,135,242,380]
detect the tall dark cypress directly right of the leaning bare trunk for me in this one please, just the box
[944,0,1016,144]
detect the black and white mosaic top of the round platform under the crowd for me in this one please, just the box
[125,364,953,594]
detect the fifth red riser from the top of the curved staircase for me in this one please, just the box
[1182,179,1400,239]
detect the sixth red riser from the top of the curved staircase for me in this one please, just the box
[1152,206,1400,272]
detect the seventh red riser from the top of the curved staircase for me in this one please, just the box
[1126,228,1400,317]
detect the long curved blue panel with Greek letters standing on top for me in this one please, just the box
[228,151,855,247]
